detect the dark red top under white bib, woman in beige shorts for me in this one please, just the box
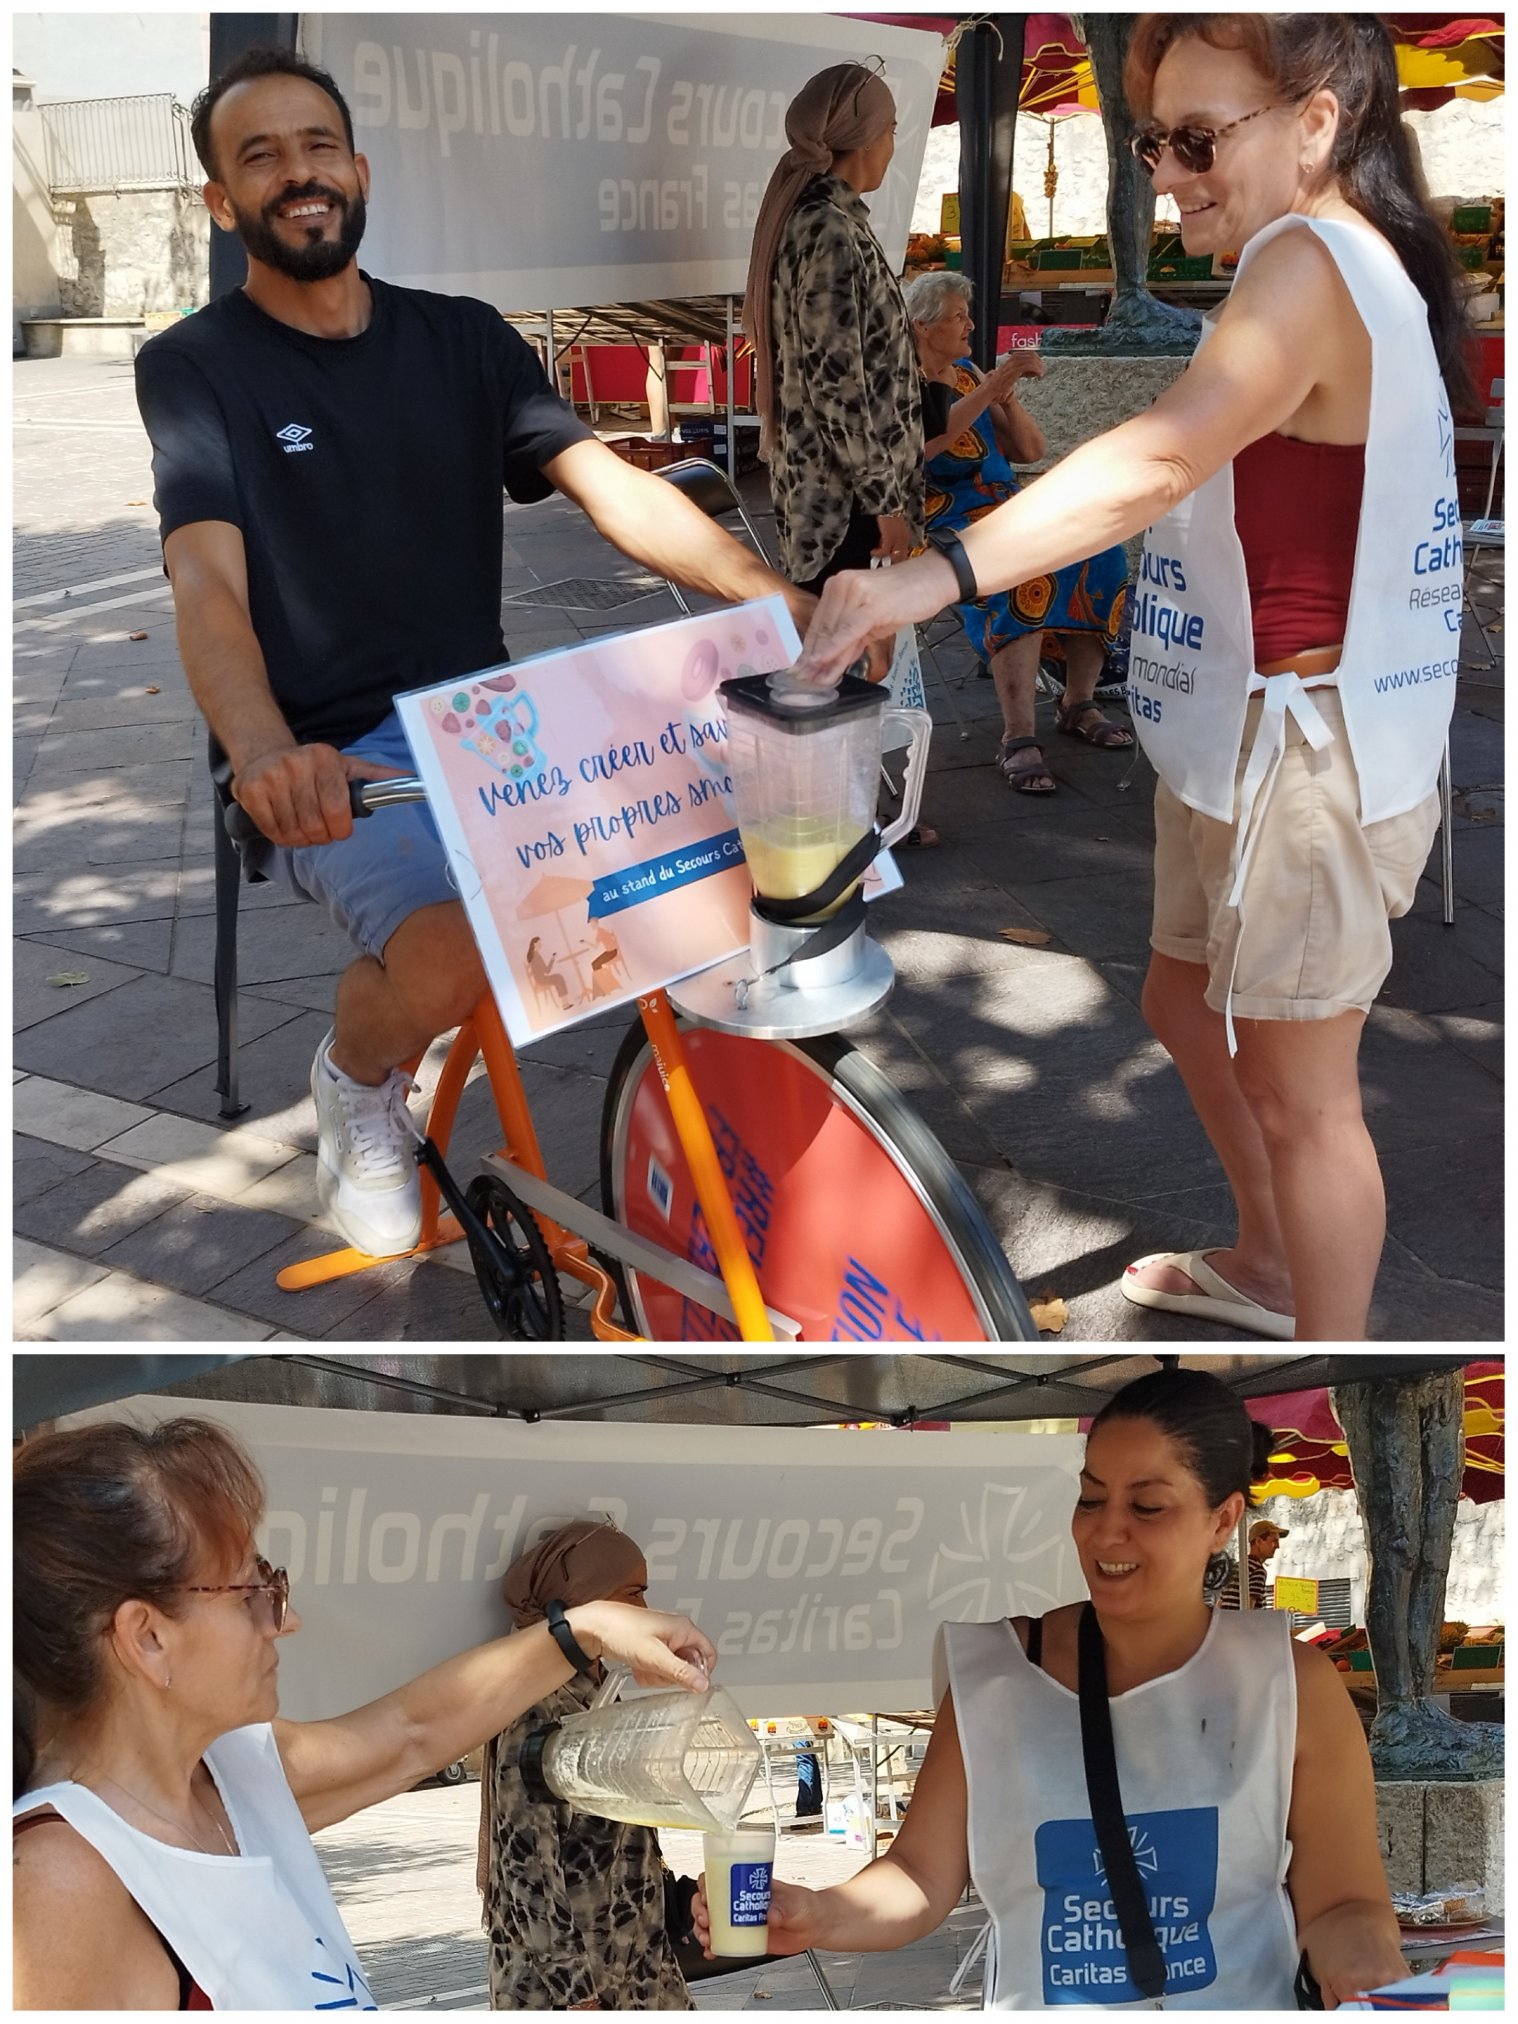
[1233,435,1364,668]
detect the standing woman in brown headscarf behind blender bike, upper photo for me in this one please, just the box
[743,63,937,844]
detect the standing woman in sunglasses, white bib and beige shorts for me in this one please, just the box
[802,14,1469,1340]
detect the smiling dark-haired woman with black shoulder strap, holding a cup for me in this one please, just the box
[696,1370,1403,2010]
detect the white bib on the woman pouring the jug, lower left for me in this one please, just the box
[10,1722,378,2010]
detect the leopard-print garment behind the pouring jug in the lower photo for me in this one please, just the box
[486,1678,696,2010]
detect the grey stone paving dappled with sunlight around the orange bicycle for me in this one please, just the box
[12,358,1504,1342]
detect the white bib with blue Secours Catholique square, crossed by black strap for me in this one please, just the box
[947,1611,1297,2010]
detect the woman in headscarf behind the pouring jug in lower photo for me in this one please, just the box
[478,1520,696,2010]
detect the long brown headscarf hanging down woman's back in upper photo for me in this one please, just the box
[743,63,897,457]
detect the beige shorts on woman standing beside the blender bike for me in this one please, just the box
[1150,688,1439,1020]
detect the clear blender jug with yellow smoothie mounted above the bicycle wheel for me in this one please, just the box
[721,674,933,921]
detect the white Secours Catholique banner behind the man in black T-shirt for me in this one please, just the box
[300,10,943,310]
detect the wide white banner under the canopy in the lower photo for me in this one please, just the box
[71,1397,1085,1720]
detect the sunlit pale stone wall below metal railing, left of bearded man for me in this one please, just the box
[55,190,210,316]
